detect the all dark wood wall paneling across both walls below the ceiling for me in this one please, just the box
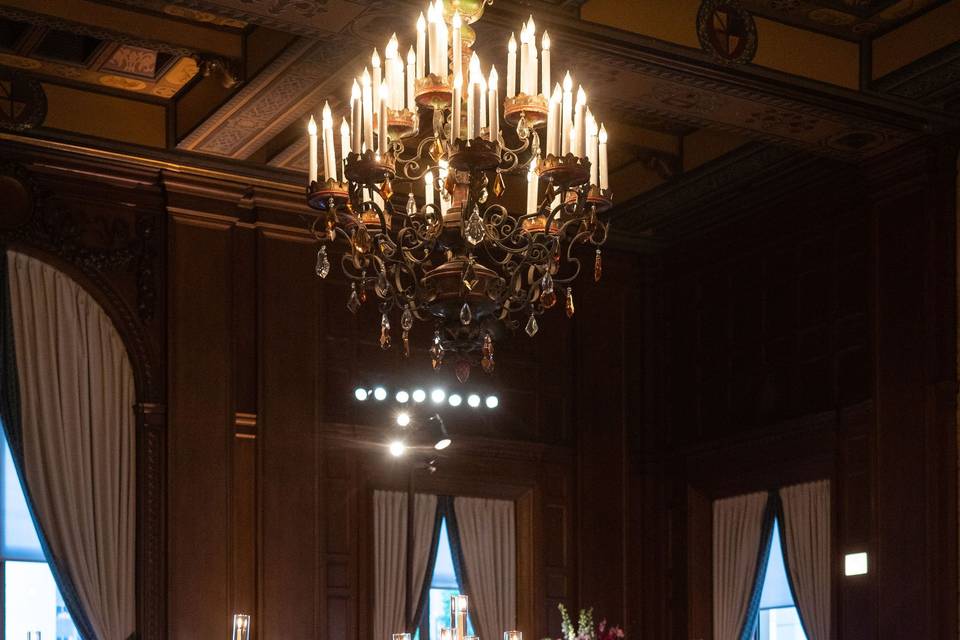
[3,135,957,640]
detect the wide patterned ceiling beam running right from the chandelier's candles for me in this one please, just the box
[476,3,952,161]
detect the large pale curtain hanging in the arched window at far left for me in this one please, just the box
[6,251,136,640]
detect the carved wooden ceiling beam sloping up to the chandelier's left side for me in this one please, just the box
[177,36,358,159]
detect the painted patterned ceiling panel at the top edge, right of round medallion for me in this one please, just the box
[740,0,945,40]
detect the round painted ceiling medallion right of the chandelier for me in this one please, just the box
[697,0,757,64]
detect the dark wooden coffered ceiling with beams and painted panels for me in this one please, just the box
[0,0,960,248]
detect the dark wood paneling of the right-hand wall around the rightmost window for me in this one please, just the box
[631,142,957,639]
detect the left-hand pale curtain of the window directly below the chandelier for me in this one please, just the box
[373,491,437,640]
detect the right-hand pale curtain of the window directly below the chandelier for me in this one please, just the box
[453,498,517,638]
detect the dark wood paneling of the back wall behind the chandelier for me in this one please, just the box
[156,166,644,640]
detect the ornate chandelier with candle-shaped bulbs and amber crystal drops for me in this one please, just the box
[307,0,613,381]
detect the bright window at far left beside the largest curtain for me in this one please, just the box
[0,435,80,640]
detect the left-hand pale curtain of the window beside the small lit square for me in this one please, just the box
[713,493,768,640]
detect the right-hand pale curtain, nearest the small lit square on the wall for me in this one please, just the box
[780,480,831,640]
